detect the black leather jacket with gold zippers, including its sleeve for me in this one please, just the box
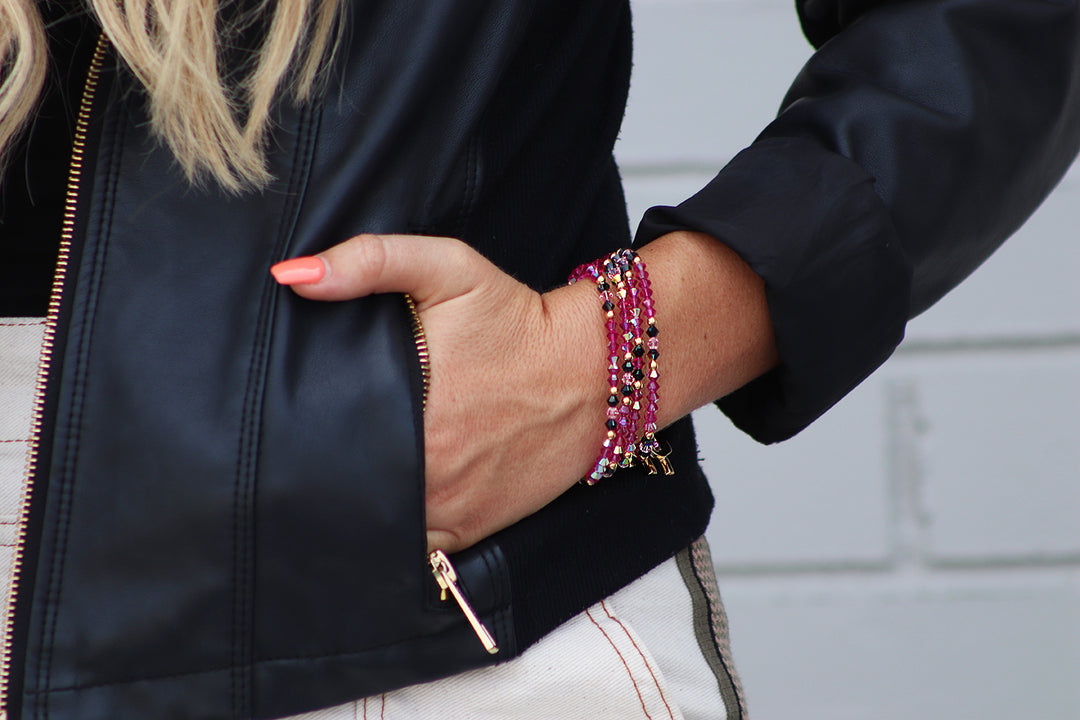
[9,0,1080,720]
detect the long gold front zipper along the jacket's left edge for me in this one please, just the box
[0,32,108,720]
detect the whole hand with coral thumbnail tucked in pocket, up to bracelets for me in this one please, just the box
[274,235,607,552]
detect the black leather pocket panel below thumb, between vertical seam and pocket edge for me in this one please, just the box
[253,296,431,661]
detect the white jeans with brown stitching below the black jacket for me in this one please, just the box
[0,318,746,720]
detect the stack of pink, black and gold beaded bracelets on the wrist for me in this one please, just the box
[570,249,674,485]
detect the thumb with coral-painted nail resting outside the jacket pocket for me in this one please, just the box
[270,234,487,310]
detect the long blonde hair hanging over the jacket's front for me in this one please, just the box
[0,0,343,192]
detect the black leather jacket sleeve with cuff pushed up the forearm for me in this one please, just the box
[637,0,1080,443]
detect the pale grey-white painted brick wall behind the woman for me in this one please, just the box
[618,0,1080,720]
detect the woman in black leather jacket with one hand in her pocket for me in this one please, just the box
[0,0,1080,718]
